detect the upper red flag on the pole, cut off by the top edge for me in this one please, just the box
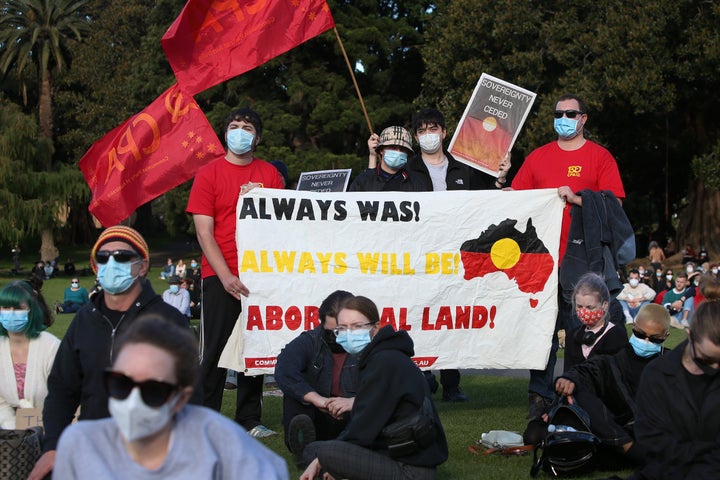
[162,0,335,95]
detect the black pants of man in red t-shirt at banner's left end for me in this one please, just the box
[200,277,263,430]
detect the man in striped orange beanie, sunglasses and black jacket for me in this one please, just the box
[29,225,189,479]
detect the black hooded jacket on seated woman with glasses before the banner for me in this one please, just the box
[338,326,448,467]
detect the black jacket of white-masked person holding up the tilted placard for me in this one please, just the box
[405,151,495,192]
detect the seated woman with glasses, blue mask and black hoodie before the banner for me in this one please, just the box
[300,296,448,480]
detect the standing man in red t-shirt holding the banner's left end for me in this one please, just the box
[187,108,283,437]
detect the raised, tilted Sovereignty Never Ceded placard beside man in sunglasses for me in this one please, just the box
[448,73,536,177]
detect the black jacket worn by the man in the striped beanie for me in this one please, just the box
[43,279,189,451]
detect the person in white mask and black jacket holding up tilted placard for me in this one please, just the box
[407,108,510,402]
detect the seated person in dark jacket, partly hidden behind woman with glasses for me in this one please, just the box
[275,290,358,468]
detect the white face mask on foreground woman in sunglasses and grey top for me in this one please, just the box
[108,387,179,442]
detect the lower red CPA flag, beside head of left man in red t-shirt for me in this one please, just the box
[80,84,224,227]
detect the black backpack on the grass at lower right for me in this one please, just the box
[530,397,600,477]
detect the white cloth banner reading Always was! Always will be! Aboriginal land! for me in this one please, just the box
[220,189,563,375]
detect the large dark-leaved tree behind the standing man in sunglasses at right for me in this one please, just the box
[416,0,720,246]
